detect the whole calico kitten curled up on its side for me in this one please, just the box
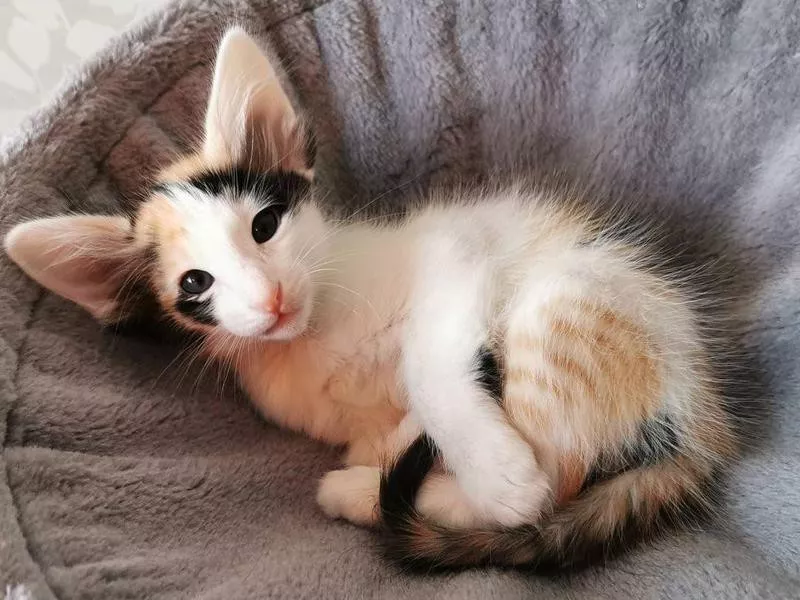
[5,28,736,568]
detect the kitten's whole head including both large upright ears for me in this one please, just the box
[5,29,327,340]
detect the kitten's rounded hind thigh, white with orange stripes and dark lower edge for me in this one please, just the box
[503,265,679,504]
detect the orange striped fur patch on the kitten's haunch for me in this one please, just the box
[504,299,661,496]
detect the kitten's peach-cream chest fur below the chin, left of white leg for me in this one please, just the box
[239,230,409,443]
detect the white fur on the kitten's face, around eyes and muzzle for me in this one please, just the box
[155,185,324,340]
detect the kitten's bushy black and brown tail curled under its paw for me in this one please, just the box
[380,436,719,570]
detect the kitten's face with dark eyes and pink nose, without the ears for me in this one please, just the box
[135,169,326,341]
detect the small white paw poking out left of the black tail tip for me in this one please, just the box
[317,466,381,526]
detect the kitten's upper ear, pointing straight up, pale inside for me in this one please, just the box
[203,27,313,178]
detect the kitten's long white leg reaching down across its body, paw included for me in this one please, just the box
[402,232,551,526]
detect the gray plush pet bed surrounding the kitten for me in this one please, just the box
[0,0,800,600]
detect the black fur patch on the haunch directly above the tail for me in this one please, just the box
[581,415,679,492]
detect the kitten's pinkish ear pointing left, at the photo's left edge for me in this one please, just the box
[4,216,143,322]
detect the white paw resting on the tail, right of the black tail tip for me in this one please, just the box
[456,431,552,527]
